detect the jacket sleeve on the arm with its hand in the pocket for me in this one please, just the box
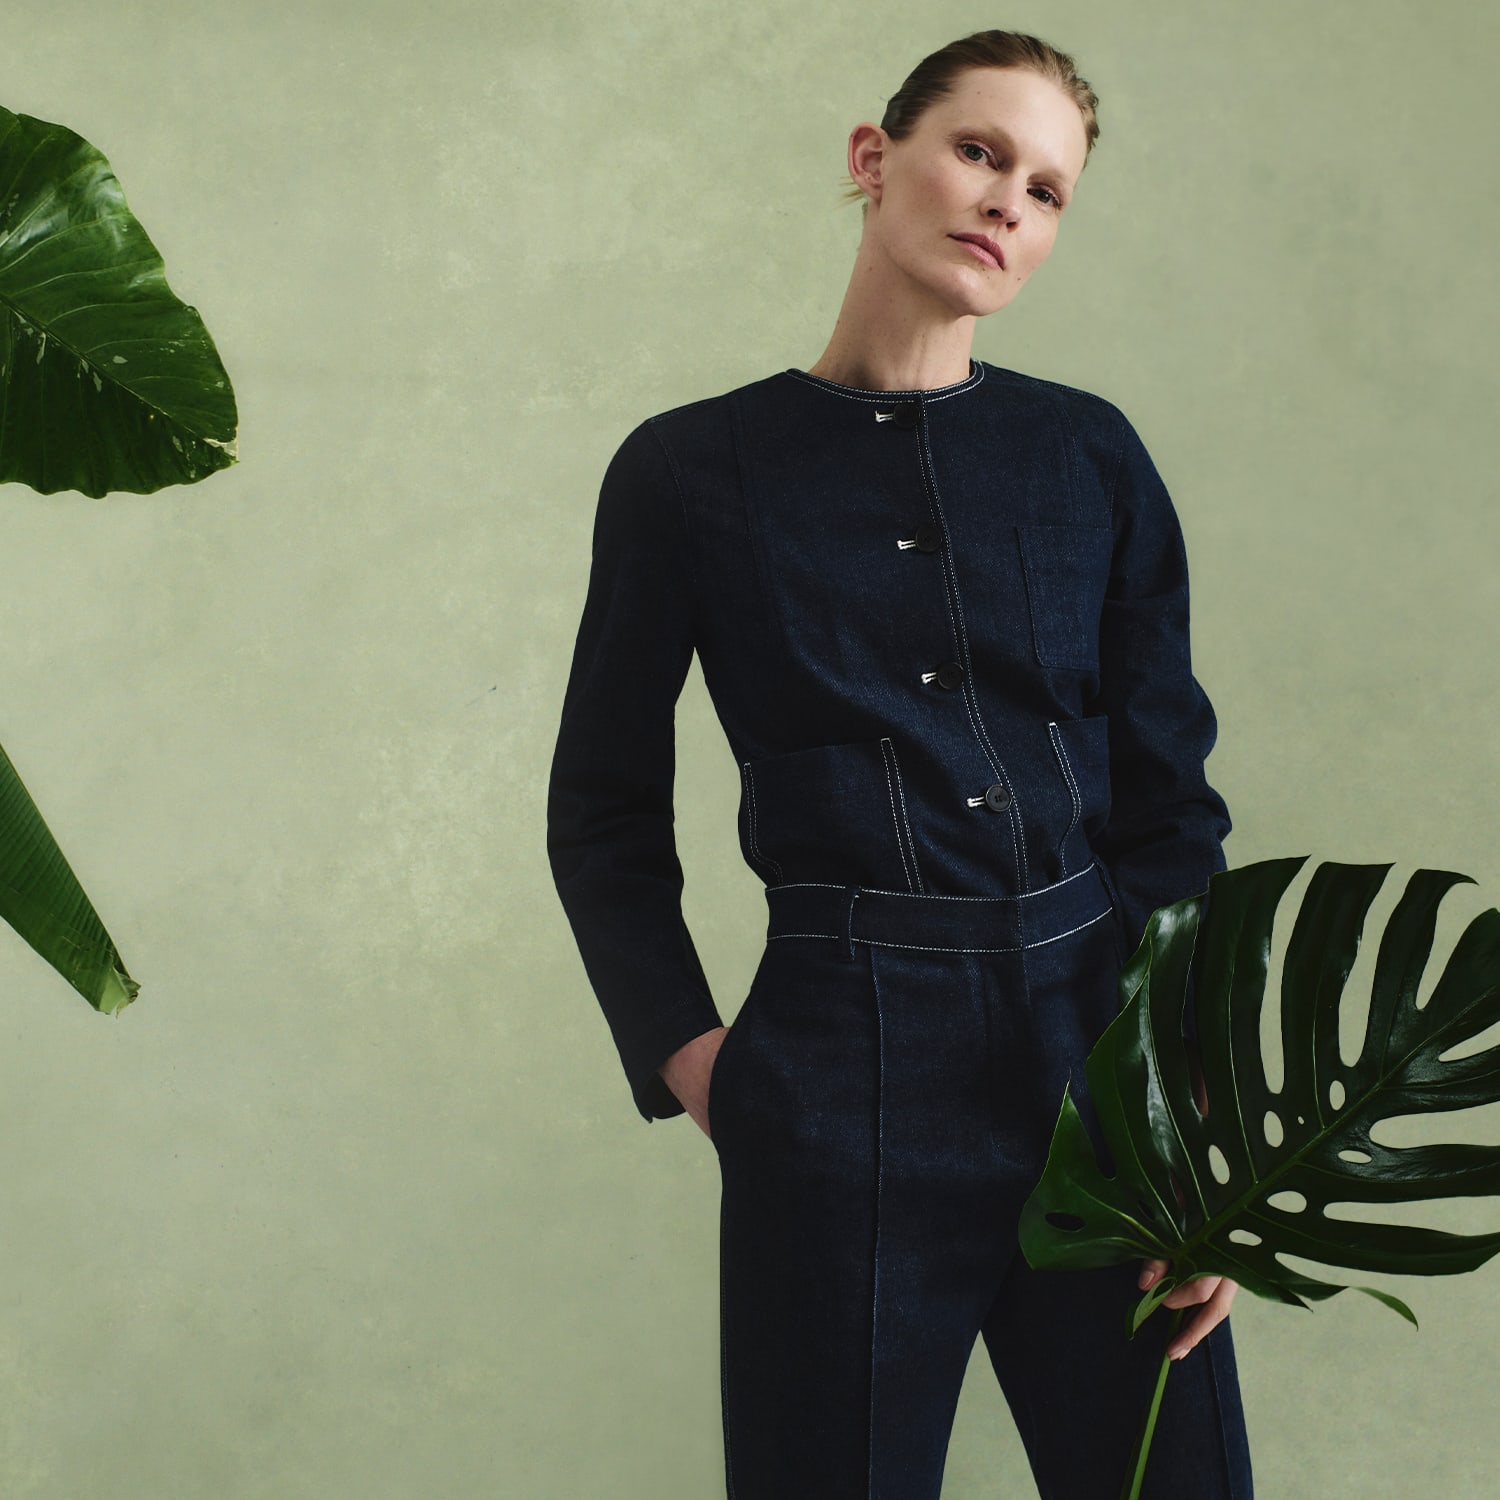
[548,422,720,1121]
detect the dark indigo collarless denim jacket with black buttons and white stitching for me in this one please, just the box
[548,363,1230,1121]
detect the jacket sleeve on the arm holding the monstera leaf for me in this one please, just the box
[1094,416,1230,996]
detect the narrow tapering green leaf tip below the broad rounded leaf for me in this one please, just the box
[0,750,140,1011]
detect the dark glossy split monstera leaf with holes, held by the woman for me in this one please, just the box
[1020,858,1500,1331]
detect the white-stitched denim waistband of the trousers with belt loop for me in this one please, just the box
[765,864,1113,959]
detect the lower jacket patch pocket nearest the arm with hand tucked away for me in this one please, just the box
[740,738,923,893]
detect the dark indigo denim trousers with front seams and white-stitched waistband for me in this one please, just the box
[710,866,1251,1500]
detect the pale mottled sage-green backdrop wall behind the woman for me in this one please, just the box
[0,0,1500,1500]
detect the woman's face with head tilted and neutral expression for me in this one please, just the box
[849,68,1088,318]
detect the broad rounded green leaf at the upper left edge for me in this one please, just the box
[0,110,239,495]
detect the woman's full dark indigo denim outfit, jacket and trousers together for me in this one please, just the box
[548,363,1251,1500]
